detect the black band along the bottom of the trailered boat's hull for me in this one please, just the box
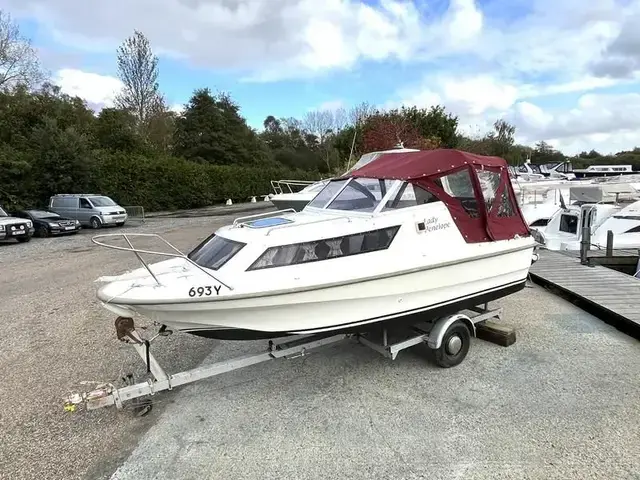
[180,280,526,340]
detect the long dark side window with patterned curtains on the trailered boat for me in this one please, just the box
[247,225,400,271]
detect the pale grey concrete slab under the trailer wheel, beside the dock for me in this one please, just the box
[112,287,640,480]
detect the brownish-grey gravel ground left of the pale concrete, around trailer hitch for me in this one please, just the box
[0,213,255,479]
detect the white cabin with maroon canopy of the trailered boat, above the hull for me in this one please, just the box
[189,149,532,281]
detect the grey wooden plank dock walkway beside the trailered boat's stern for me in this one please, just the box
[530,249,640,338]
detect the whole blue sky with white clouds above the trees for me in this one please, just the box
[1,0,640,155]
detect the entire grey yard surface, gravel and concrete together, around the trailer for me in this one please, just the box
[0,207,640,480]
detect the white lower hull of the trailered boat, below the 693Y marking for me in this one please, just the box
[105,246,533,340]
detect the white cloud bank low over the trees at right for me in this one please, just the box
[392,75,640,154]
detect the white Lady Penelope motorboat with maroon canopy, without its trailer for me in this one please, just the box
[93,149,536,340]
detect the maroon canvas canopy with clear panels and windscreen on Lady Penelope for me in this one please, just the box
[307,149,529,242]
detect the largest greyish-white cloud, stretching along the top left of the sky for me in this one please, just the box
[5,0,483,80]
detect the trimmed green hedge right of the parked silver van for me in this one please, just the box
[92,153,320,211]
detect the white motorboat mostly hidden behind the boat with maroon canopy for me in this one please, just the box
[269,143,418,212]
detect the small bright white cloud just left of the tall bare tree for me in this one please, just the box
[53,68,122,108]
